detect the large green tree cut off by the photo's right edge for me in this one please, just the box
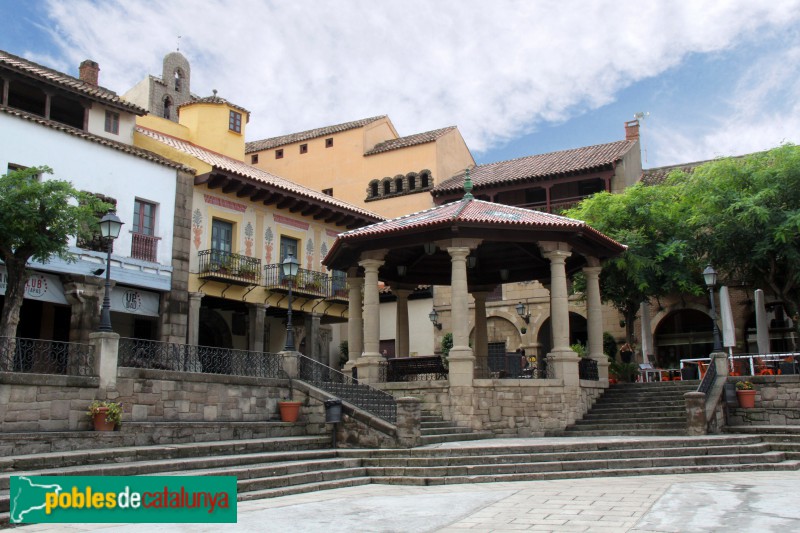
[668,144,800,323]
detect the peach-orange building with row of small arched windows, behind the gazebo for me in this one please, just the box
[246,116,475,218]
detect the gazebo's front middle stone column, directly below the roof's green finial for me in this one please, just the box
[447,246,475,387]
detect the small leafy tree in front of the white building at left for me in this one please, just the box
[0,167,110,337]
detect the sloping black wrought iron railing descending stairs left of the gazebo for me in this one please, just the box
[298,355,397,424]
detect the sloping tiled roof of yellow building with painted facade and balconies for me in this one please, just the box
[136,126,383,220]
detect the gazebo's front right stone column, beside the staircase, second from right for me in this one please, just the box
[539,242,578,387]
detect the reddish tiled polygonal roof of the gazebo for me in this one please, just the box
[339,199,624,250]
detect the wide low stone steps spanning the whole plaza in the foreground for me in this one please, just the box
[6,435,800,523]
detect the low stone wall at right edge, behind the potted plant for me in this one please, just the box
[728,375,800,426]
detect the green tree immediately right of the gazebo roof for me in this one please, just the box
[564,184,703,342]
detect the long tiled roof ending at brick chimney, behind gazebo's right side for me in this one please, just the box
[431,140,636,196]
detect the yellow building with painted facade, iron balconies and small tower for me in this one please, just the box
[134,94,381,366]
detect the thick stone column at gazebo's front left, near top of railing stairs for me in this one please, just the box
[356,254,384,384]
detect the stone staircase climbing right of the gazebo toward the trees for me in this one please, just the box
[549,381,700,436]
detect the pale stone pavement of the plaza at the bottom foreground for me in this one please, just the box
[14,472,800,533]
